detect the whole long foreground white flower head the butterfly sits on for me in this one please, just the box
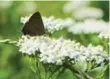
[17,36,107,65]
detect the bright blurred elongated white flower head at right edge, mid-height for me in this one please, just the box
[68,19,109,34]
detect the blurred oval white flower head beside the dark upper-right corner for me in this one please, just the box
[73,7,103,20]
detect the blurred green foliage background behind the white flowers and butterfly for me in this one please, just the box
[0,1,109,79]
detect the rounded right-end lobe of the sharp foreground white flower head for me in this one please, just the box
[82,44,107,64]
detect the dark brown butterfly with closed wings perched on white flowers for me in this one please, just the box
[22,12,45,36]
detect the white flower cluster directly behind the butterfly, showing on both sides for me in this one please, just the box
[21,16,74,33]
